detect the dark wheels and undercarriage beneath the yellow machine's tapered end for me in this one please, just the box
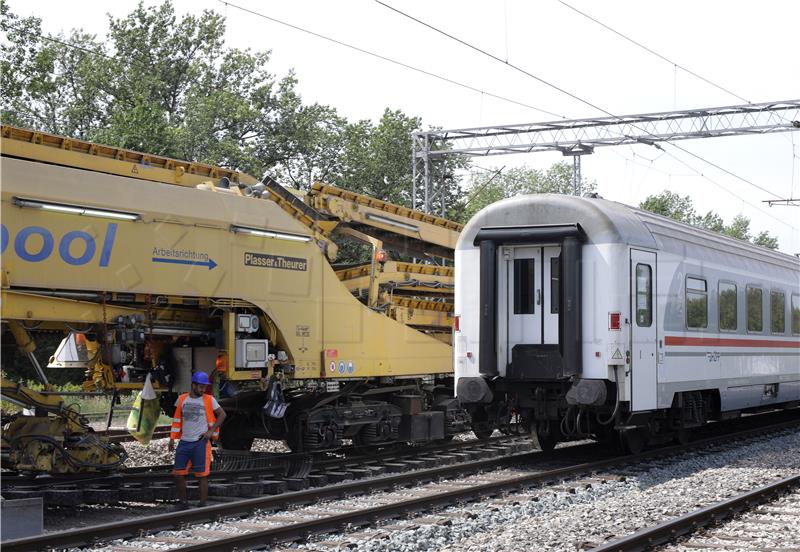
[220,377,470,452]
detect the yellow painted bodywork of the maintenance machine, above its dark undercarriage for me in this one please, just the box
[0,125,461,392]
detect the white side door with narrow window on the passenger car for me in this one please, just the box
[630,249,658,410]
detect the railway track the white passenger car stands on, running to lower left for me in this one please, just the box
[3,412,798,551]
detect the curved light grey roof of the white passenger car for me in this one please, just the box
[456,194,800,270]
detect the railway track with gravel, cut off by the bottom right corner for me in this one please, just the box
[591,475,800,552]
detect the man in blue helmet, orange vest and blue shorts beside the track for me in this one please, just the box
[169,372,225,509]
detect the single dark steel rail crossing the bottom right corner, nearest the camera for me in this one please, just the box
[588,475,800,552]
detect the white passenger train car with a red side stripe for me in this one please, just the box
[454,194,800,449]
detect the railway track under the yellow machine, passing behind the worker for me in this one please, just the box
[2,436,533,507]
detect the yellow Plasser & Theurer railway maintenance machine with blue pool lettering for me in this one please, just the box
[1,126,467,469]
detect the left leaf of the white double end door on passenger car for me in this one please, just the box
[497,246,542,367]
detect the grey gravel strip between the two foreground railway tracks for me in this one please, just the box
[300,432,800,552]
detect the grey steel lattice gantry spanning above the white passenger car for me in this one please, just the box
[412,100,800,214]
